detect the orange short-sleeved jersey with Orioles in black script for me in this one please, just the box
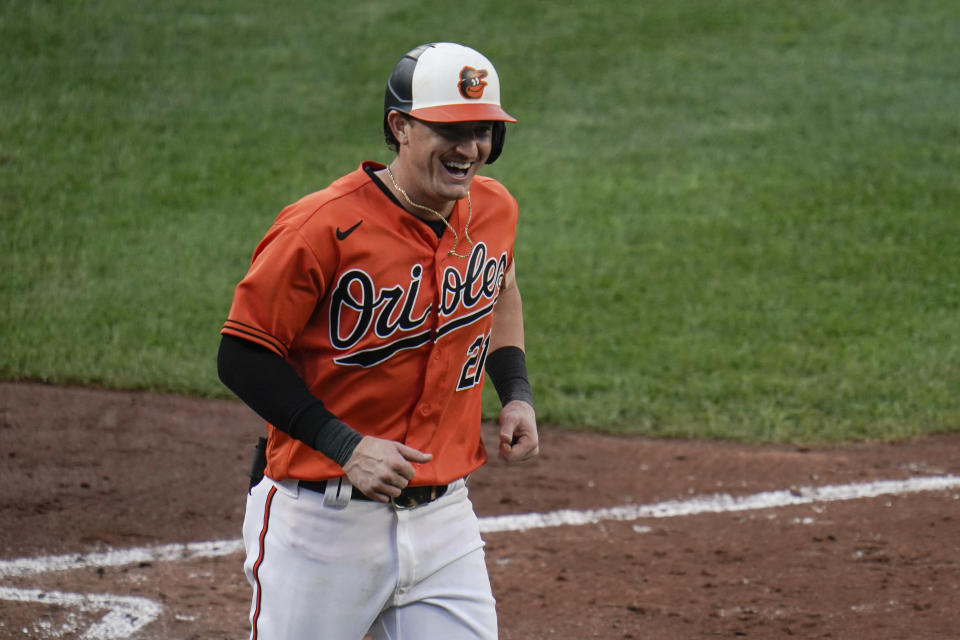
[221,162,517,486]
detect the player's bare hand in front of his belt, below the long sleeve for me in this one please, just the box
[343,436,433,502]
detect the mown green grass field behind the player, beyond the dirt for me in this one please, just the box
[0,0,960,442]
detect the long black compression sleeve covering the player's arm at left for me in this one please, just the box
[217,335,363,466]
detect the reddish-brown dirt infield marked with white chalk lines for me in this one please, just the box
[0,383,960,640]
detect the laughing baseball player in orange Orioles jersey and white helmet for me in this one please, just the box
[218,43,539,640]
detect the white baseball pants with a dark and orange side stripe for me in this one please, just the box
[243,477,497,640]
